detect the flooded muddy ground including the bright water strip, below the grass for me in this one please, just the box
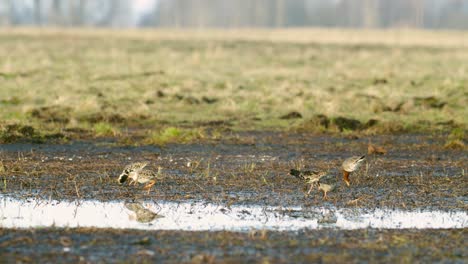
[0,132,468,262]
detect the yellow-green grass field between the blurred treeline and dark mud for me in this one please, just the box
[0,29,468,142]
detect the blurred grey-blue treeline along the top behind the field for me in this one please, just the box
[0,0,468,29]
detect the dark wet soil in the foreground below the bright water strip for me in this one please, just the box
[0,228,468,263]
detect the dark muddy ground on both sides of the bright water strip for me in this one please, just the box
[0,132,468,263]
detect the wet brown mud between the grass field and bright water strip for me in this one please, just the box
[0,132,468,210]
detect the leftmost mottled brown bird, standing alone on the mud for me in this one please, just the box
[119,162,161,193]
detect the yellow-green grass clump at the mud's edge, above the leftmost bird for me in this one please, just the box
[144,127,205,145]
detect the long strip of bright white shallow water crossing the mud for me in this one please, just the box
[0,197,468,231]
